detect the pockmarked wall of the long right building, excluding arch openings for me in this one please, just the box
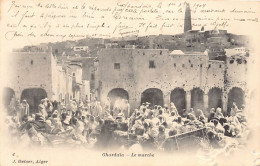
[98,48,246,113]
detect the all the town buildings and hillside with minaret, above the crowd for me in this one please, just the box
[1,5,253,116]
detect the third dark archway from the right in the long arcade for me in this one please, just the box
[191,88,204,110]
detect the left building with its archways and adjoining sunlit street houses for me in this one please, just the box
[4,47,90,111]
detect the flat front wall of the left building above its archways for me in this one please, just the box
[12,52,52,98]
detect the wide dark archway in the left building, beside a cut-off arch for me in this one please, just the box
[21,88,47,113]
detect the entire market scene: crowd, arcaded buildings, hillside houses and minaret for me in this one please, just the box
[3,2,255,156]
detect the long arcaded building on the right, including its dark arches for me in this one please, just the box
[97,48,250,115]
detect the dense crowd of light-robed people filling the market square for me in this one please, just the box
[3,98,250,152]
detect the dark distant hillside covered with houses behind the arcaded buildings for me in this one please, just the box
[18,29,250,59]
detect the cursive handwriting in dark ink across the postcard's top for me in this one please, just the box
[3,0,259,40]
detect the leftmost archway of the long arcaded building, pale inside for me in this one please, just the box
[107,88,129,108]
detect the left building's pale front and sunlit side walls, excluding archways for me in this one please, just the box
[4,52,72,104]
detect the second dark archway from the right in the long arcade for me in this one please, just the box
[208,88,222,109]
